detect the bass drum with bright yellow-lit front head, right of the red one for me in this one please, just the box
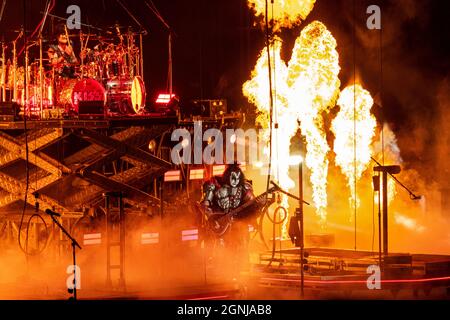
[106,76,146,114]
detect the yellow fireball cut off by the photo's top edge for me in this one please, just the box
[248,0,316,30]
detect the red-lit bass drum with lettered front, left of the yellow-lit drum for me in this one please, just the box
[58,79,106,114]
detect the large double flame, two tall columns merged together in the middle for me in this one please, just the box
[243,21,340,222]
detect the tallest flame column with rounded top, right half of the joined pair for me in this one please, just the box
[288,21,340,223]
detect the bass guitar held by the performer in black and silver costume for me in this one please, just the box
[197,184,280,237]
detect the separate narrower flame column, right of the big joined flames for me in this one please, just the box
[331,85,377,211]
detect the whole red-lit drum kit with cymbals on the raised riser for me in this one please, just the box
[0,25,146,119]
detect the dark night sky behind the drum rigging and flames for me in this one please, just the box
[0,0,450,184]
